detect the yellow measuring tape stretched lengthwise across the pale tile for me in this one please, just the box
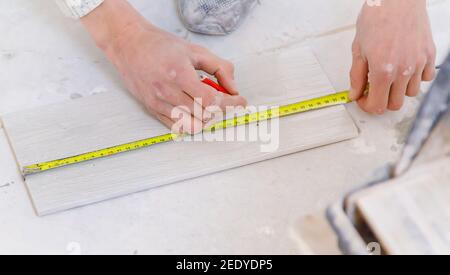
[22,91,350,176]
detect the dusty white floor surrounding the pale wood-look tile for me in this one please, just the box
[0,0,450,254]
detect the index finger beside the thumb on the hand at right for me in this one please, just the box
[357,64,394,115]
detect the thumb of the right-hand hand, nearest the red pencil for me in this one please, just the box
[349,51,369,101]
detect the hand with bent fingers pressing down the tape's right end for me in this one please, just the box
[350,0,436,114]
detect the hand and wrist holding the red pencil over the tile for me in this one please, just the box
[85,0,246,134]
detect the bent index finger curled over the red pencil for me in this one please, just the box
[195,48,239,95]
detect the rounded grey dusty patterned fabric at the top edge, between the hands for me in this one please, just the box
[178,0,257,35]
